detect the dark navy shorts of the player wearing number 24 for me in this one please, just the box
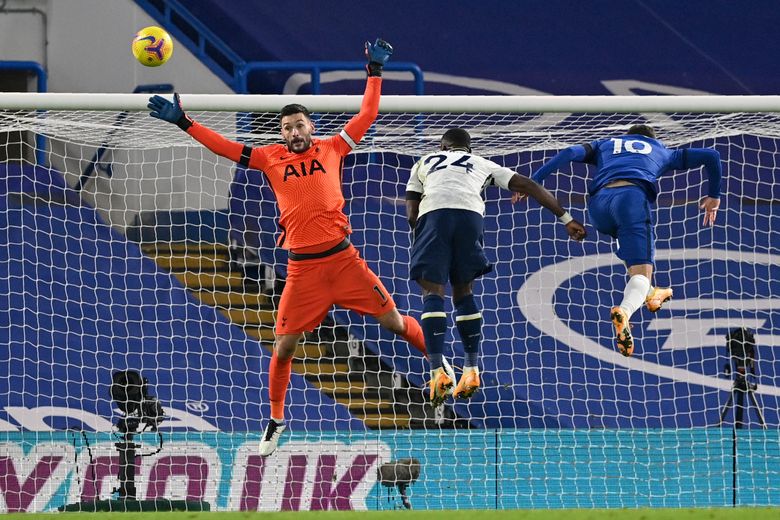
[409,209,493,285]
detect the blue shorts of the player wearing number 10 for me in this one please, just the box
[588,186,655,267]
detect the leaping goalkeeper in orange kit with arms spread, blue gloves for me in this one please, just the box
[149,39,454,456]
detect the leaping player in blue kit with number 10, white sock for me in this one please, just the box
[531,125,721,356]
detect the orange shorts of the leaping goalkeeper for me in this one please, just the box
[276,245,395,334]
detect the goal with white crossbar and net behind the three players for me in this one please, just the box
[0,93,780,512]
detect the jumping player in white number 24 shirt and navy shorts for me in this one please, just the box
[406,128,585,406]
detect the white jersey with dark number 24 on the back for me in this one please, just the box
[406,150,515,217]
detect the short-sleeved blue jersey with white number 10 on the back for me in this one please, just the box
[583,134,685,201]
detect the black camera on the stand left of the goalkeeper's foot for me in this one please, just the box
[111,370,165,432]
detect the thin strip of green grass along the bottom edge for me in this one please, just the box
[24,508,780,520]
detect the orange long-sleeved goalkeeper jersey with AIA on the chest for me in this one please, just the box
[187,77,382,249]
